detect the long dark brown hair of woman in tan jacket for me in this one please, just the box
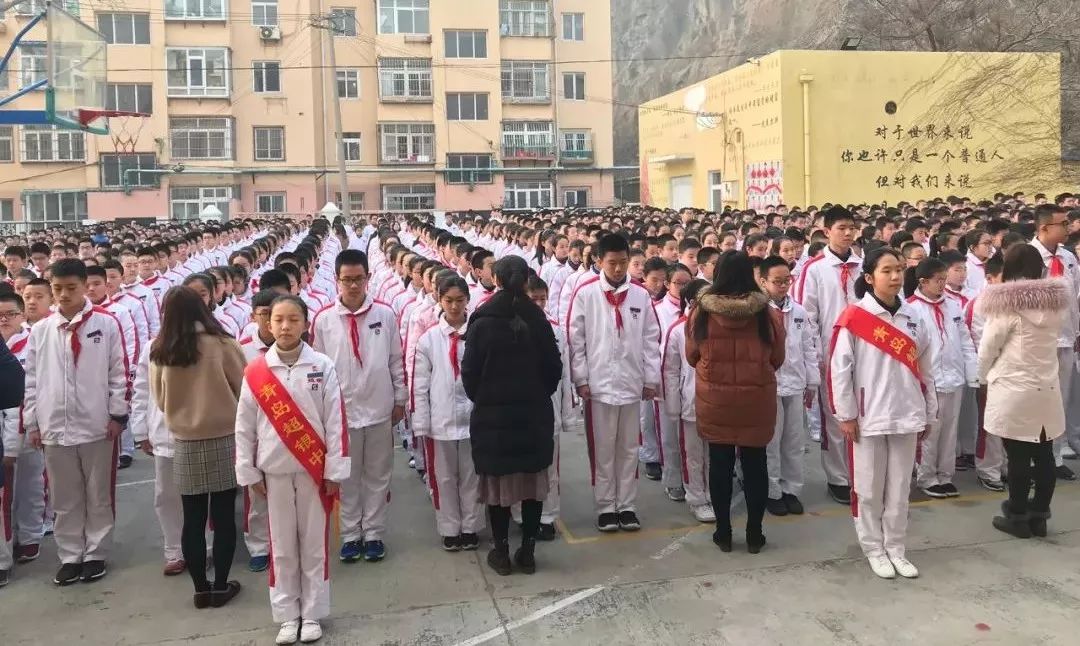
[150,286,230,367]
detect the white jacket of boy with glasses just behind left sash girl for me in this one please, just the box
[311,294,408,429]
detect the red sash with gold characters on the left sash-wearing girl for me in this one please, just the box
[244,354,334,513]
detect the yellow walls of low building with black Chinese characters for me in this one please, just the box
[639,51,1061,208]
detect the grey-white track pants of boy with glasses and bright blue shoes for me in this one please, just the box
[341,419,394,542]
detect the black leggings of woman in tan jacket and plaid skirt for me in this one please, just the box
[180,488,237,592]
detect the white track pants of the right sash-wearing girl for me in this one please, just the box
[847,433,918,558]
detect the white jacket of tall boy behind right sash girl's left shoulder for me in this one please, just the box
[795,246,862,354]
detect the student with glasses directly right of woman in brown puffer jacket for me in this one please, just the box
[758,256,821,516]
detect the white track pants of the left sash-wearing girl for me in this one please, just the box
[266,473,328,623]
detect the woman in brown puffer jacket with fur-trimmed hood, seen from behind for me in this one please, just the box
[686,252,784,554]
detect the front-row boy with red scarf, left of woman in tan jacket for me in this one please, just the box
[23,258,129,586]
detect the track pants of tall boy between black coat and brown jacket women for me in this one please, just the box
[584,400,642,514]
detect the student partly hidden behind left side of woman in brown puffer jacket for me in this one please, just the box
[661,279,716,523]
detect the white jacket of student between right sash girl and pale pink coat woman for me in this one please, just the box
[907,290,978,392]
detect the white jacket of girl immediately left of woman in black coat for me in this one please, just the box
[411,317,472,440]
